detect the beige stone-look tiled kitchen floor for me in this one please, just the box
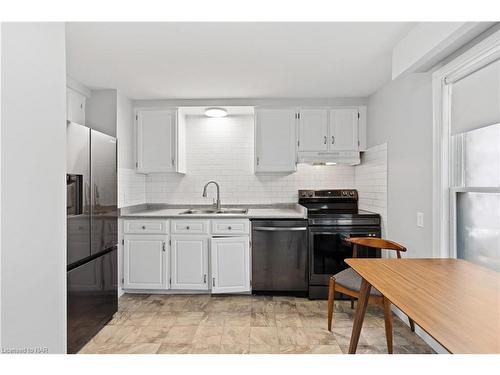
[80,294,433,354]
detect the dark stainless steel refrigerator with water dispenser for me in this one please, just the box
[66,122,118,353]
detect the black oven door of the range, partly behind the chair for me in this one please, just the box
[309,227,380,285]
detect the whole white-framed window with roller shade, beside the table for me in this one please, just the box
[433,31,500,271]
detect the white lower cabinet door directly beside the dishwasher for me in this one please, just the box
[210,236,250,293]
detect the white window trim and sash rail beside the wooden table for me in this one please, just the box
[432,30,500,258]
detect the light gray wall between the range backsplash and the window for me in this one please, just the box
[367,73,432,257]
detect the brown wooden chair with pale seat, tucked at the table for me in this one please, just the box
[328,237,415,354]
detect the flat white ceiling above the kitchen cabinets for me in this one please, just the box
[66,22,414,99]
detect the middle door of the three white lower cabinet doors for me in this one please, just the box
[171,236,208,290]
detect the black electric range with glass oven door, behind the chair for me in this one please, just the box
[299,189,381,299]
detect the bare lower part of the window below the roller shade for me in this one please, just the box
[450,124,500,271]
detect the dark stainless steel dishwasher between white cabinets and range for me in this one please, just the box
[252,220,309,296]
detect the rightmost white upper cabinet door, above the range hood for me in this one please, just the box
[329,108,358,151]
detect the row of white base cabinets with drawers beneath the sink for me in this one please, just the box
[122,219,250,293]
